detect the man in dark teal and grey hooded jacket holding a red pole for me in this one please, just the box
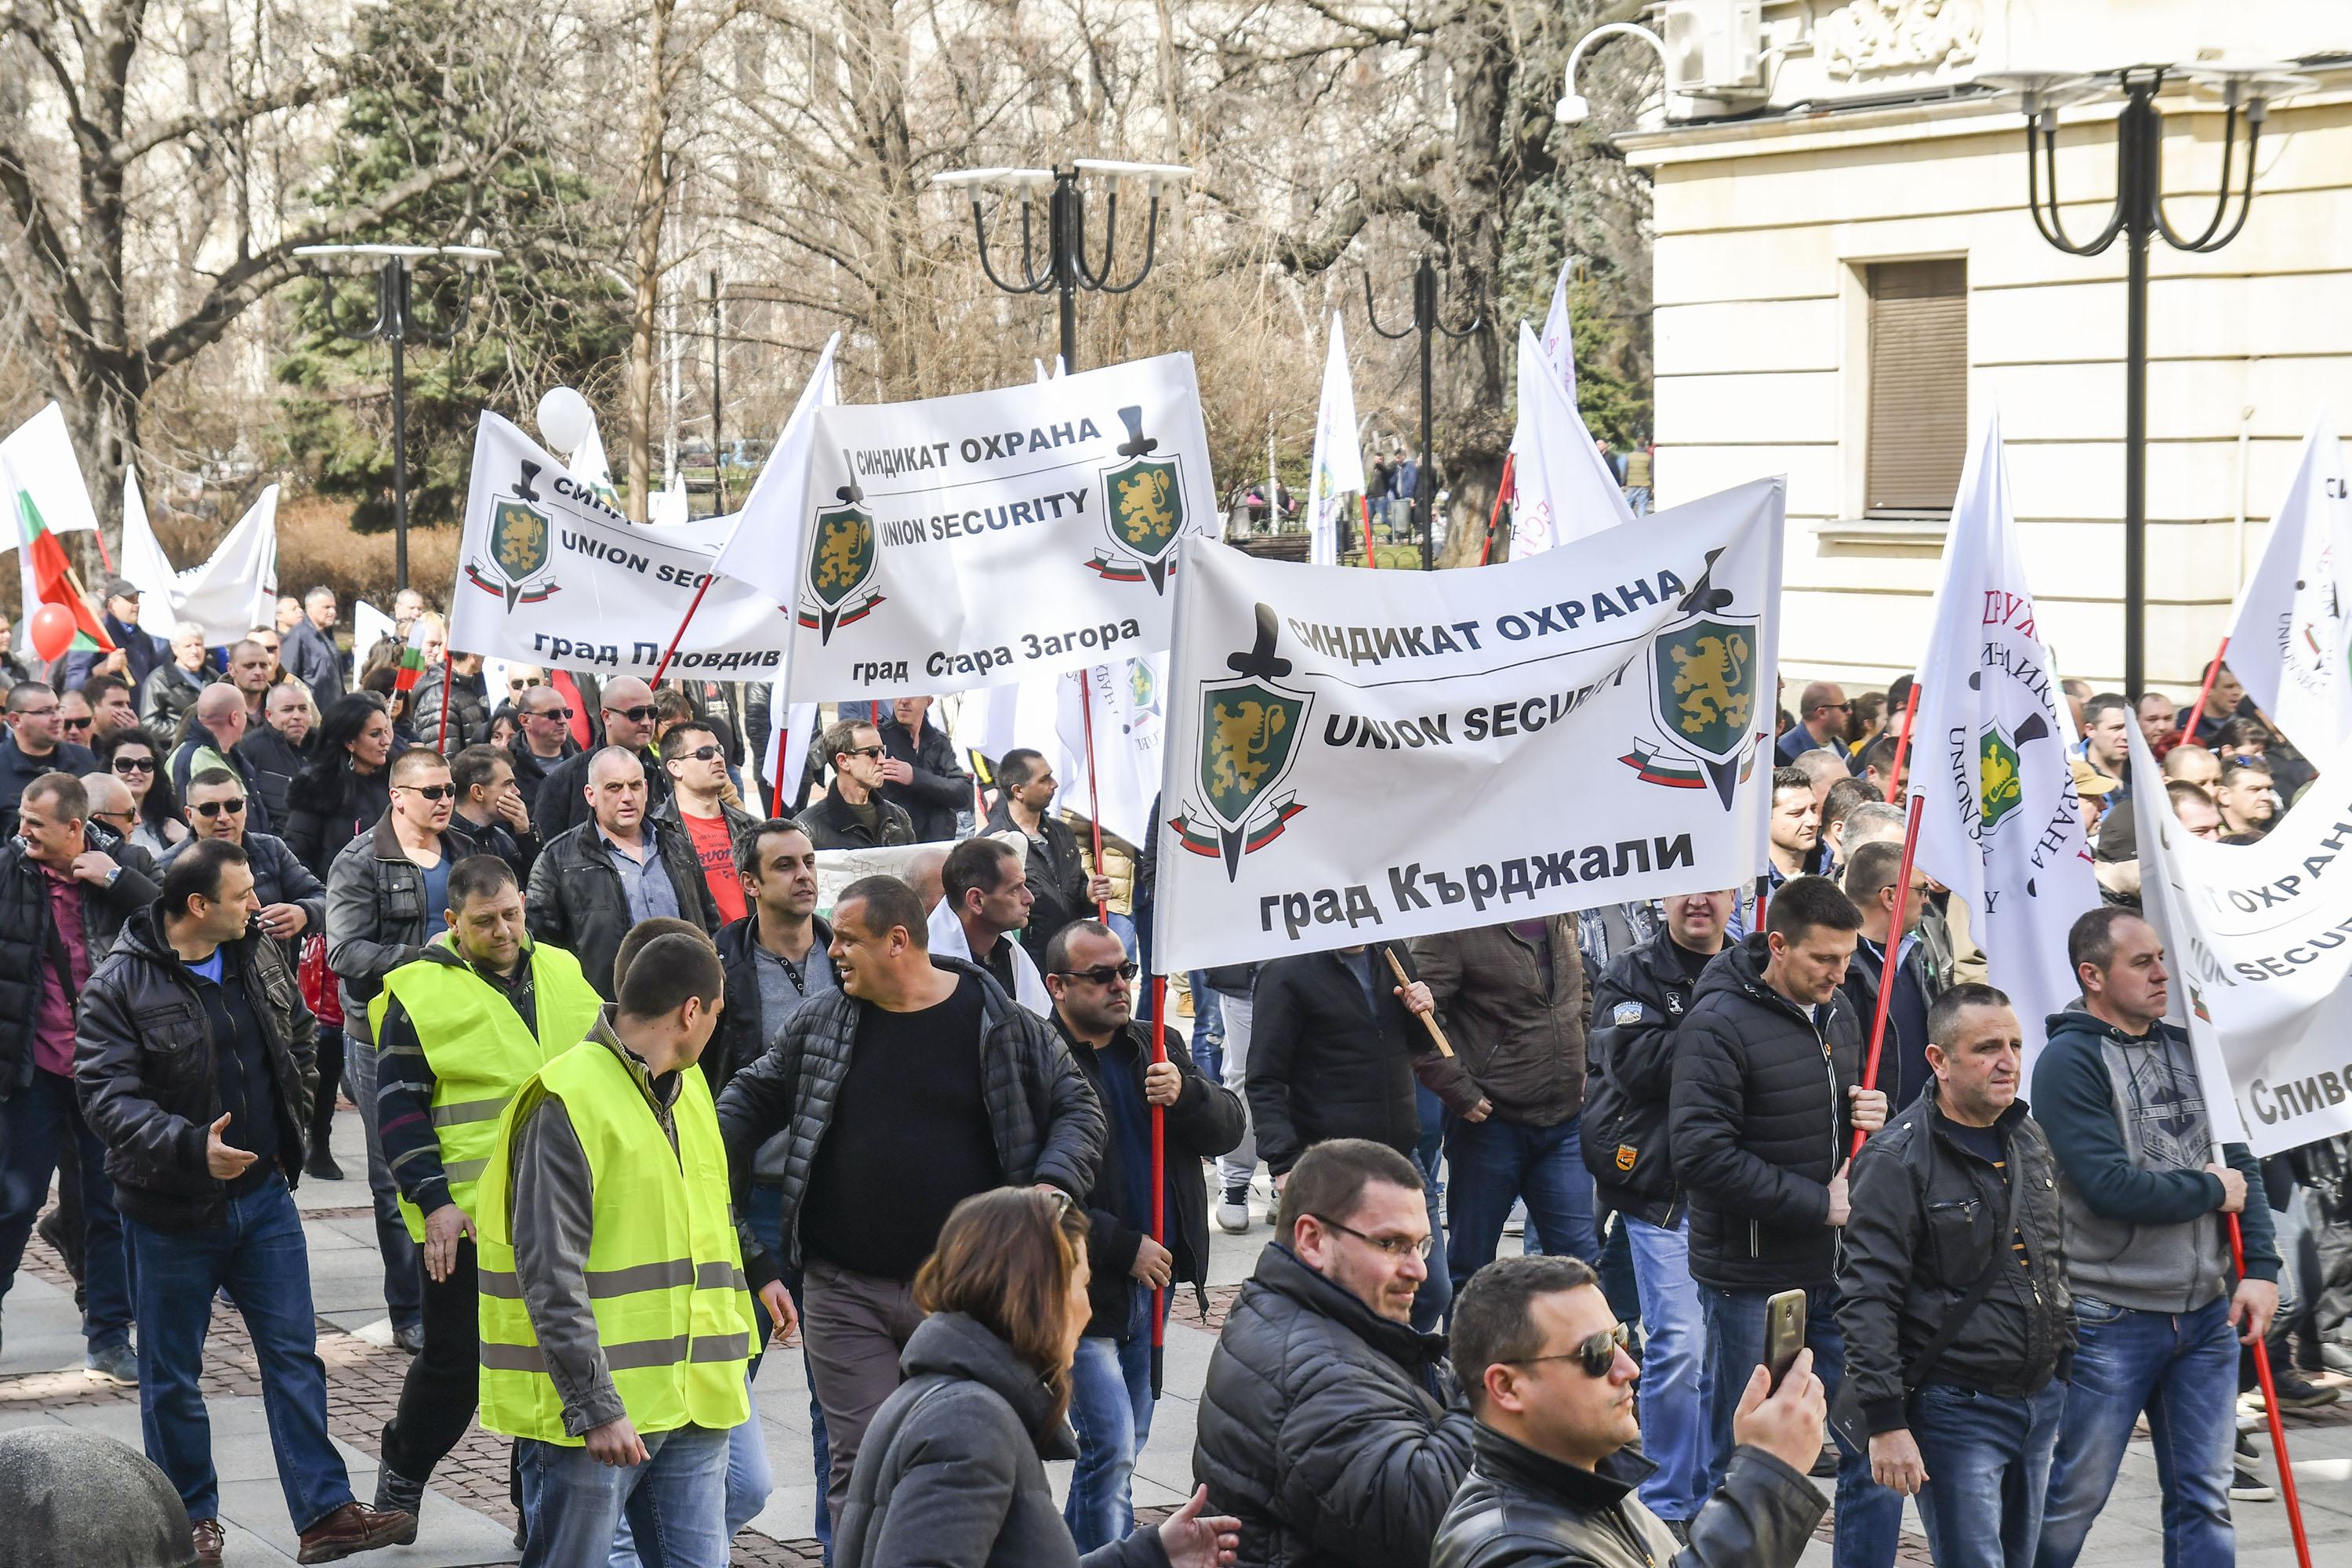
[2034,905,2279,1568]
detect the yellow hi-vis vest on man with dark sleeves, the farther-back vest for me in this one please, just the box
[367,933,602,1241]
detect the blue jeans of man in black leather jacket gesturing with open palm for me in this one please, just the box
[127,1173,350,1530]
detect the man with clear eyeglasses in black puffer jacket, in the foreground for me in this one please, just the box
[1192,1138,1472,1568]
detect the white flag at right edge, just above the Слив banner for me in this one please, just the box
[2230,412,2352,757]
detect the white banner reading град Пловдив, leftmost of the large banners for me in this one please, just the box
[449,412,788,680]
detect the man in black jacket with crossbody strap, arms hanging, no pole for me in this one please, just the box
[1837,987,2074,1568]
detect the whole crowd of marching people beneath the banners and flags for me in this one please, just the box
[0,581,2352,1568]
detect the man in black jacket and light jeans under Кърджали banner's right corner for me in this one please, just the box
[1583,891,1738,1526]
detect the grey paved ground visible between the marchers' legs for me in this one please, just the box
[13,1107,2352,1568]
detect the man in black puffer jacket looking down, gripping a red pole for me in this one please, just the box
[1668,877,1903,1568]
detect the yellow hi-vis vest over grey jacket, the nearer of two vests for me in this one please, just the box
[475,1039,753,1446]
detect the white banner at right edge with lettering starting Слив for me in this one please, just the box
[2131,727,2352,1154]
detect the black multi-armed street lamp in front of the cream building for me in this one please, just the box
[1978,64,2312,701]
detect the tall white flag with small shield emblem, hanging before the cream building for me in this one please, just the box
[1910,414,2098,1072]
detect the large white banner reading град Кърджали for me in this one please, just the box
[1155,480,1783,973]
